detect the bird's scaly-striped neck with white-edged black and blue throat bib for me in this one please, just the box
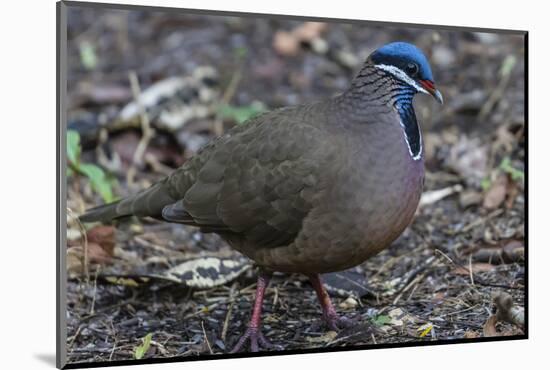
[340,63,422,160]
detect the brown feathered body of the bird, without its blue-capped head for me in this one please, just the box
[81,44,439,347]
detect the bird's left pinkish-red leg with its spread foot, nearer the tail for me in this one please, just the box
[231,274,274,353]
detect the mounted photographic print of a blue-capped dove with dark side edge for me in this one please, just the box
[57,1,527,368]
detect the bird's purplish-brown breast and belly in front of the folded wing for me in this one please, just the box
[255,120,424,273]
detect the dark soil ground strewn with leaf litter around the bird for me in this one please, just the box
[67,8,526,363]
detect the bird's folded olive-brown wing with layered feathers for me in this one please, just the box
[162,104,333,247]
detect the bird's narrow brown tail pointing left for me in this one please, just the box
[79,182,175,222]
